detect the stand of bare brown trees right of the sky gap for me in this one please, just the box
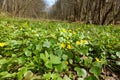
[49,0,120,25]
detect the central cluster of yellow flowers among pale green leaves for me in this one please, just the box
[59,28,88,49]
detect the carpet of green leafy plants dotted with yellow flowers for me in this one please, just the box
[0,18,120,80]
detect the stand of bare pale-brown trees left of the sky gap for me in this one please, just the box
[0,0,45,17]
